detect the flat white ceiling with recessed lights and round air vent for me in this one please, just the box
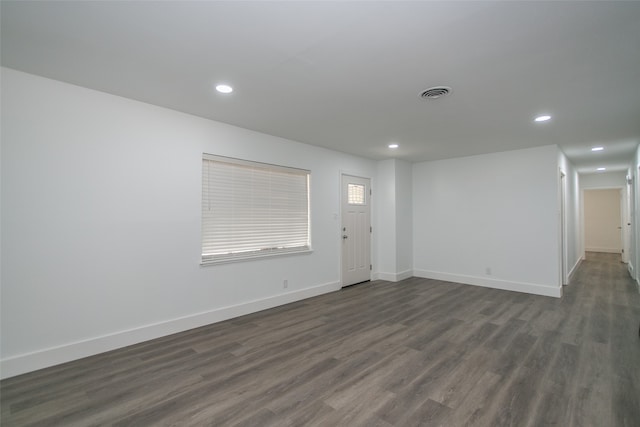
[0,1,640,173]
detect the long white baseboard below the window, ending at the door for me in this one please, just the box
[0,282,340,379]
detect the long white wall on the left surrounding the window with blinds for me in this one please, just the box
[1,69,376,377]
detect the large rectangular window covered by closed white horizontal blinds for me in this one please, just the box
[202,154,311,264]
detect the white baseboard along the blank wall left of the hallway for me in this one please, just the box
[413,270,562,298]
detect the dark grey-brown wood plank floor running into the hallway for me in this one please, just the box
[0,253,640,427]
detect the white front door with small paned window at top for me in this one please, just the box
[341,175,371,286]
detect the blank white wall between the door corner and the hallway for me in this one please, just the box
[413,146,562,296]
